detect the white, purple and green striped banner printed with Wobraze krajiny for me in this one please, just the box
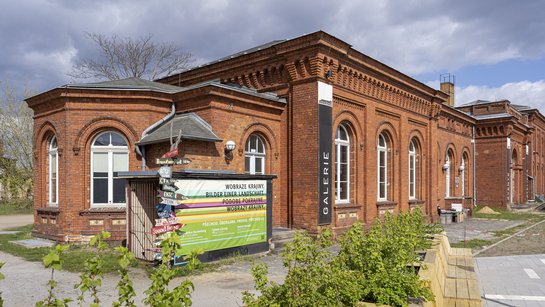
[168,179,267,254]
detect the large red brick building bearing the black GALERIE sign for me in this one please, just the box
[27,31,545,241]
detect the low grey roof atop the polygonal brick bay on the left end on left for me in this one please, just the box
[62,77,183,94]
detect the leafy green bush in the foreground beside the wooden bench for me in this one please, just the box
[243,211,439,306]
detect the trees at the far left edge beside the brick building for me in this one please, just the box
[0,83,33,200]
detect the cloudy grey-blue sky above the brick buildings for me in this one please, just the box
[0,0,545,106]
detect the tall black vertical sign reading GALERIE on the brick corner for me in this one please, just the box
[318,81,334,225]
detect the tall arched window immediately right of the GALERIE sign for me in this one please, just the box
[335,125,350,203]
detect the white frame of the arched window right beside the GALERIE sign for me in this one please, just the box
[335,125,350,203]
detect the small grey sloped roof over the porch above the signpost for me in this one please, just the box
[136,113,222,145]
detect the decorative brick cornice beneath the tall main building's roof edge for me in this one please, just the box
[159,31,448,118]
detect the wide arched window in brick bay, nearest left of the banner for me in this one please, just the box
[91,131,129,206]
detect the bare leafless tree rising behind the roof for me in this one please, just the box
[68,33,194,80]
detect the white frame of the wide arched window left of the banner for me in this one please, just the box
[90,131,130,207]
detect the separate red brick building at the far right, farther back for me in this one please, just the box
[458,100,545,207]
